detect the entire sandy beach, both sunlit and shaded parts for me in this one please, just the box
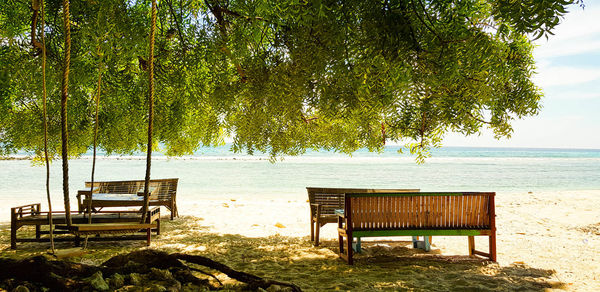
[0,191,600,291]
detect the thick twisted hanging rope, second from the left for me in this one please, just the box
[60,0,71,227]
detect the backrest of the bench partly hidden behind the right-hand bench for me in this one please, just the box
[306,187,419,215]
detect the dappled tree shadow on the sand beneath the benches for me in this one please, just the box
[0,216,565,291]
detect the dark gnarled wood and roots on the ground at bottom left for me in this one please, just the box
[0,249,302,291]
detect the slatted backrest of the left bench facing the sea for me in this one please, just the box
[85,178,179,201]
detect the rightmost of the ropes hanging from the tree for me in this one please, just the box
[141,0,156,223]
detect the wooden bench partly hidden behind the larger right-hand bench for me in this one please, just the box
[306,187,419,246]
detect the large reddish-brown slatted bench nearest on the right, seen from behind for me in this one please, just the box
[338,192,496,265]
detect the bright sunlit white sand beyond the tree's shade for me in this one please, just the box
[178,190,600,291]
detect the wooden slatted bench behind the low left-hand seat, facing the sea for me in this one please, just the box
[77,178,179,220]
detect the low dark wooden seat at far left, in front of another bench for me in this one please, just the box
[10,203,160,249]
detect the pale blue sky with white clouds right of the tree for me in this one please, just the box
[443,4,600,149]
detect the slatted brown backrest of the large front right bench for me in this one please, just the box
[344,192,495,230]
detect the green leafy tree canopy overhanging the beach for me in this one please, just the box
[0,0,583,158]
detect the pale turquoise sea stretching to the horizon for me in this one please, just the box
[0,145,600,222]
